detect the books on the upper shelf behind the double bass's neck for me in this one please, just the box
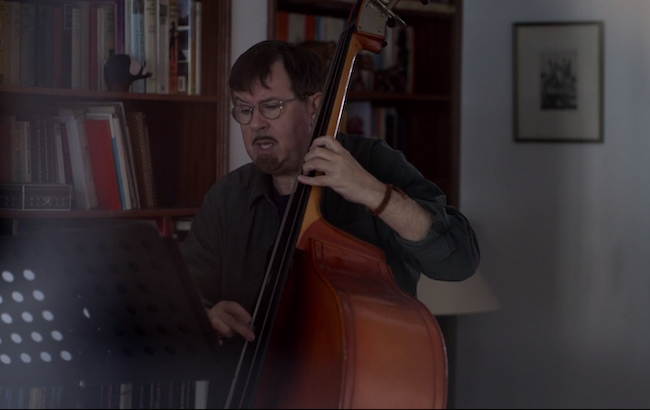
[276,11,415,93]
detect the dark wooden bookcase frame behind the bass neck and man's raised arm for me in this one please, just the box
[268,0,462,206]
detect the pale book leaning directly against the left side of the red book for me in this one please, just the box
[59,108,97,209]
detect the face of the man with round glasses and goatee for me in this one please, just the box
[233,61,320,177]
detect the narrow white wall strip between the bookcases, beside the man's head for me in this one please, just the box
[229,0,268,170]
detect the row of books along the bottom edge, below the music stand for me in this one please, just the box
[0,380,209,409]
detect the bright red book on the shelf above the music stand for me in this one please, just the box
[86,118,122,210]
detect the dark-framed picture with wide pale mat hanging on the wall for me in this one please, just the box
[514,21,604,142]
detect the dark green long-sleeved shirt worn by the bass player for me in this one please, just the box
[182,134,479,312]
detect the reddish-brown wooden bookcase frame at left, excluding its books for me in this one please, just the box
[0,0,231,237]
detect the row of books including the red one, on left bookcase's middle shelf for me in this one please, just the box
[0,102,157,210]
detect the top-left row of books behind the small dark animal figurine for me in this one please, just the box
[0,0,201,94]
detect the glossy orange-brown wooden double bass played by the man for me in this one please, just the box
[225,0,447,408]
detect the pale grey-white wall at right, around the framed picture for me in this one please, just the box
[456,0,650,408]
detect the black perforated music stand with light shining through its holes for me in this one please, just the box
[0,223,218,402]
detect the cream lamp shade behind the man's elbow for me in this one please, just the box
[418,271,499,316]
